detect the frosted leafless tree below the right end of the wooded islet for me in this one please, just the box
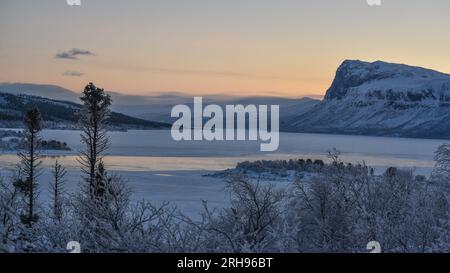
[285,160,368,252]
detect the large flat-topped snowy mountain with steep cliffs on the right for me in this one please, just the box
[282,60,450,138]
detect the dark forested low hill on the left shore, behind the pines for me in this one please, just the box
[0,93,170,130]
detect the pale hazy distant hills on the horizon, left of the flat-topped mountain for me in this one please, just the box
[0,83,320,122]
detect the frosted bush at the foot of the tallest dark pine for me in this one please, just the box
[73,166,152,252]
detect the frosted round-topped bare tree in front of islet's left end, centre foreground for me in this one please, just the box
[202,175,283,252]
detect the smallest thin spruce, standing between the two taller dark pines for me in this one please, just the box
[50,160,67,221]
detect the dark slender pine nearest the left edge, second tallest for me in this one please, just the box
[14,107,42,228]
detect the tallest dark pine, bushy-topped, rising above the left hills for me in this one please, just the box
[79,83,111,198]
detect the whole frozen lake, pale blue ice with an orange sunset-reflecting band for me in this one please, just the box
[0,130,445,217]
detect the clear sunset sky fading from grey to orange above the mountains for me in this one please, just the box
[0,0,450,97]
